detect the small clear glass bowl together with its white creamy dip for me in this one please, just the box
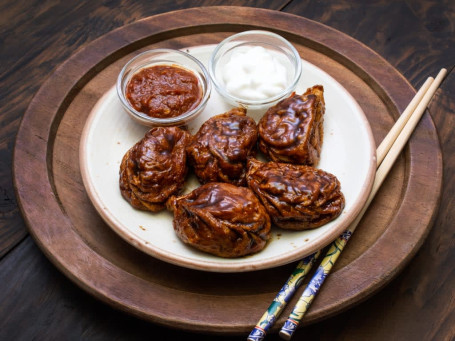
[208,30,302,109]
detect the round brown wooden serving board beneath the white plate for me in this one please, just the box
[14,7,442,333]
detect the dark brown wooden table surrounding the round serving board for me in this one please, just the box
[0,0,455,340]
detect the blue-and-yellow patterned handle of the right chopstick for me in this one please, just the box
[280,231,351,340]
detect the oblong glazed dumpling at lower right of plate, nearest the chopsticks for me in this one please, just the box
[247,159,345,230]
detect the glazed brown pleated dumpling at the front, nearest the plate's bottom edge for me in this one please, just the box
[167,182,271,258]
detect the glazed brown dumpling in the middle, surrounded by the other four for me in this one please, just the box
[187,108,257,186]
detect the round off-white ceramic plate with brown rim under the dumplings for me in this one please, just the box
[80,45,376,272]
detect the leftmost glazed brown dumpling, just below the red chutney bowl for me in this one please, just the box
[120,127,191,212]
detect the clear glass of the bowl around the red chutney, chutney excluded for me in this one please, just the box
[117,48,211,127]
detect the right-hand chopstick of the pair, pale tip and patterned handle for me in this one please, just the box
[280,69,447,340]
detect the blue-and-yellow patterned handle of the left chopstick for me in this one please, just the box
[248,251,321,341]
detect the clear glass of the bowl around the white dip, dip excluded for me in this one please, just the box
[208,30,302,109]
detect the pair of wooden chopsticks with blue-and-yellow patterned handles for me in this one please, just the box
[248,69,447,341]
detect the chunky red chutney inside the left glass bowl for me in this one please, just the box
[126,65,202,118]
